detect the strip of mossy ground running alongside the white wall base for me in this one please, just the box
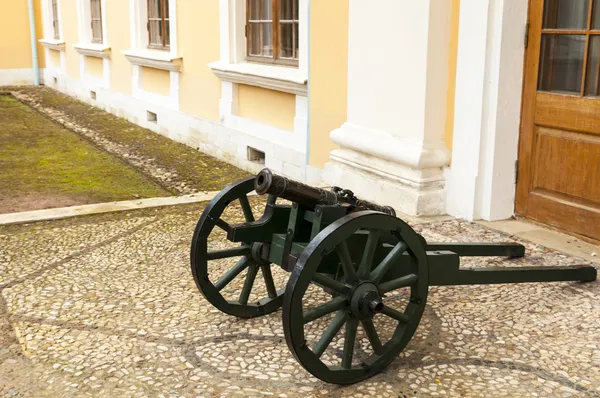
[4,87,249,191]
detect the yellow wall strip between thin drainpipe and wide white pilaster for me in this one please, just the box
[309,0,349,168]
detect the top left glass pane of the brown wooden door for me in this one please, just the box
[542,0,590,29]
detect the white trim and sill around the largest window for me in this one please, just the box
[208,0,309,96]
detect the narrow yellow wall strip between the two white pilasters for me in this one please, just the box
[444,0,460,153]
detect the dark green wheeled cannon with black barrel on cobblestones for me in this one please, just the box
[190,169,597,384]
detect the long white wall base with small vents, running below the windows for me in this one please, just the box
[39,68,322,183]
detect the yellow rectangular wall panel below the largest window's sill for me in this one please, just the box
[238,84,296,131]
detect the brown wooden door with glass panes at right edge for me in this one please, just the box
[516,0,600,240]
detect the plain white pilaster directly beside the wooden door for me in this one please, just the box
[447,0,527,220]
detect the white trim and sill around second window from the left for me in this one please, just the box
[73,0,111,58]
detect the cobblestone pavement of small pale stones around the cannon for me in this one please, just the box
[0,205,600,397]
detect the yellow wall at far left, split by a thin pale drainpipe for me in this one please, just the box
[0,0,44,69]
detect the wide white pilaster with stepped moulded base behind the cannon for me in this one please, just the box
[324,0,451,215]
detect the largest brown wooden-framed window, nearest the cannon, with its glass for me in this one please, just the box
[246,0,299,65]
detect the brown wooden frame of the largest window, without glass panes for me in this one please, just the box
[245,0,300,67]
